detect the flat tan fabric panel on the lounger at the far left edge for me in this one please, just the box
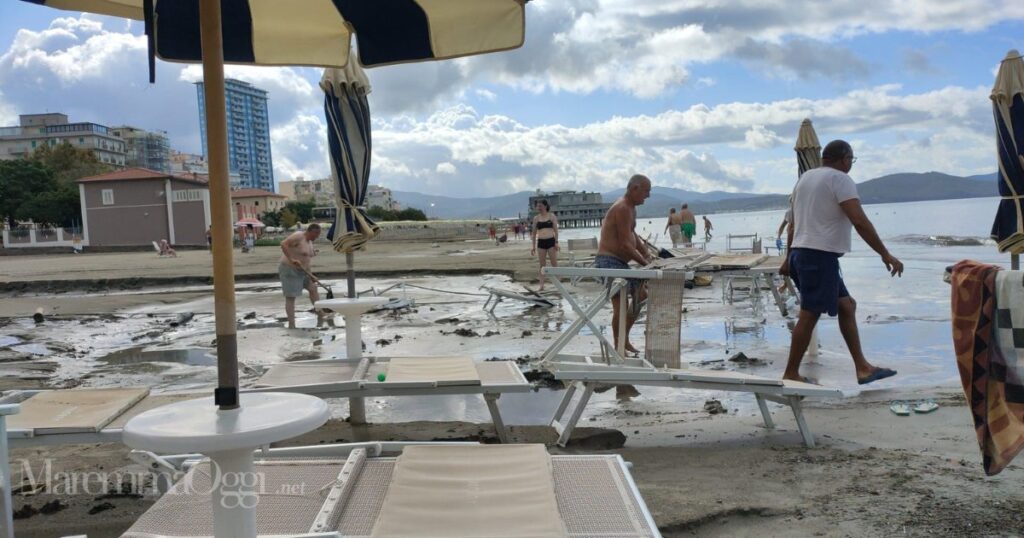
[7,388,150,434]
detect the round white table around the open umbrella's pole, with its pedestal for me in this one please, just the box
[123,392,331,538]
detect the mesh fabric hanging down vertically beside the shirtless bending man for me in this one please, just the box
[644,272,685,368]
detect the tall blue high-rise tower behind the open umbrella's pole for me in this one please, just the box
[196,79,274,193]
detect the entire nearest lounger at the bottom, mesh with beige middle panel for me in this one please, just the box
[123,443,660,538]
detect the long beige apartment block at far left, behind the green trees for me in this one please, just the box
[0,113,127,167]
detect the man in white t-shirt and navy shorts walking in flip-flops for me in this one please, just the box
[780,140,903,384]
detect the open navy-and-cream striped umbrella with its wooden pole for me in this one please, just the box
[18,0,525,409]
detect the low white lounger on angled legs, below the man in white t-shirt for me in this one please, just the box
[545,355,843,448]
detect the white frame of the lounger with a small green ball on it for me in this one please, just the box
[249,357,530,443]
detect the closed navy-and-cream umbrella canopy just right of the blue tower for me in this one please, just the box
[321,61,380,252]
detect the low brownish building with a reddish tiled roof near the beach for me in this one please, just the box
[78,168,210,247]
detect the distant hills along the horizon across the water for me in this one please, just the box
[391,172,998,219]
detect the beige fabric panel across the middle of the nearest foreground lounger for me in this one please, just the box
[372,445,565,538]
